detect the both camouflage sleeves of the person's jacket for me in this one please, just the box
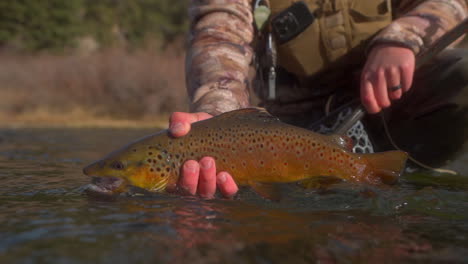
[186,0,468,115]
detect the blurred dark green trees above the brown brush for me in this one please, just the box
[0,0,187,51]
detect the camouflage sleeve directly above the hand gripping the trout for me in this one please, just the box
[185,0,254,115]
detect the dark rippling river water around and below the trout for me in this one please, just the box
[0,128,468,264]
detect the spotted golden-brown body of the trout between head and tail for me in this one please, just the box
[174,117,362,184]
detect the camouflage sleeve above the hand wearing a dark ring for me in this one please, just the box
[371,0,468,54]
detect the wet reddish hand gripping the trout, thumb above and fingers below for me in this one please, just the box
[169,112,239,199]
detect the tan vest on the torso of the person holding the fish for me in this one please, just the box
[269,0,392,77]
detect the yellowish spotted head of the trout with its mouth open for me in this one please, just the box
[83,143,174,194]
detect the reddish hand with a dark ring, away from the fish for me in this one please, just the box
[361,44,416,114]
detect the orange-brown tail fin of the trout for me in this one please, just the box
[365,150,408,184]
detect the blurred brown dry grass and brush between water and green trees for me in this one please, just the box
[0,44,187,125]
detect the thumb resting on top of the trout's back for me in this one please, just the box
[169,112,212,137]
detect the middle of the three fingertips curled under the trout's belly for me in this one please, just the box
[197,157,216,199]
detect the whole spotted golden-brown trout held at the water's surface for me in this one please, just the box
[84,108,407,194]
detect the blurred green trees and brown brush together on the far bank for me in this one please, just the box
[0,0,188,124]
